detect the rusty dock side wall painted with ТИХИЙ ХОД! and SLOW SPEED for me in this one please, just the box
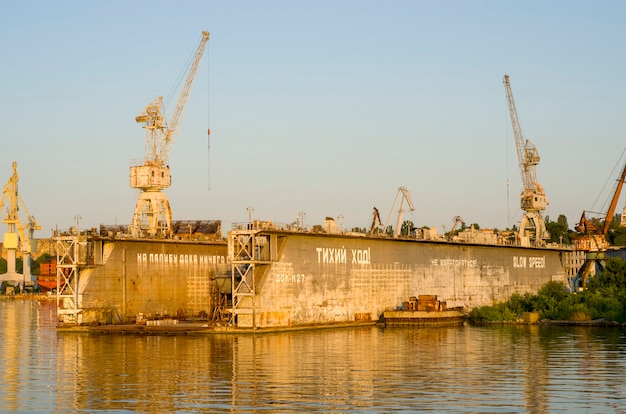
[256,234,565,327]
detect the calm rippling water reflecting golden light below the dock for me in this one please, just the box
[0,299,626,413]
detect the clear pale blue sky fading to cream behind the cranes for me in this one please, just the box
[0,1,626,237]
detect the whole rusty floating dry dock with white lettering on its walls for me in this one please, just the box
[57,219,573,331]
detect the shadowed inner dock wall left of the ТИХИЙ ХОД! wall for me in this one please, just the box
[74,241,230,323]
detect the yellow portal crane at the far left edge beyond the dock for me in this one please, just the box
[0,161,41,286]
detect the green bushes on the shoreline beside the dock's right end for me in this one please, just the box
[468,258,626,326]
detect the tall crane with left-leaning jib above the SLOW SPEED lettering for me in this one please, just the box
[503,75,550,246]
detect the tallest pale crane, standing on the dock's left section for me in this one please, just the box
[130,31,209,237]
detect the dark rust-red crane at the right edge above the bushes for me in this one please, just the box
[571,157,626,291]
